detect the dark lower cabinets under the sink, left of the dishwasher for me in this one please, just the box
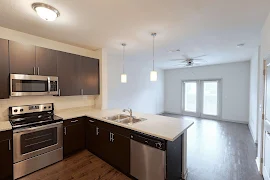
[86,119,130,174]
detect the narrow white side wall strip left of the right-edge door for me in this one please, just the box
[248,48,260,142]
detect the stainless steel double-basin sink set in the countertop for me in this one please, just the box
[104,114,146,125]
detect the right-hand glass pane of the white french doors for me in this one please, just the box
[203,81,218,116]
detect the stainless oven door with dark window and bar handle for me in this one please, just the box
[13,122,63,163]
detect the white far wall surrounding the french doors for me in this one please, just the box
[165,61,250,123]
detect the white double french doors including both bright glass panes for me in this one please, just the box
[182,80,221,119]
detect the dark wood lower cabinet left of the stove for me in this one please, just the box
[0,131,13,180]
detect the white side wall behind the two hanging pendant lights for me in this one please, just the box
[107,56,164,114]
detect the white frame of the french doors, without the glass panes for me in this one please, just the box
[181,78,222,120]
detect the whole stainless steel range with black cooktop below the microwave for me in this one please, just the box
[9,103,63,179]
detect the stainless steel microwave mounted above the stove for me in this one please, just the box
[10,74,58,96]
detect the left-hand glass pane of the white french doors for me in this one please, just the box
[185,82,197,112]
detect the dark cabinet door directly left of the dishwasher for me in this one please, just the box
[110,133,130,174]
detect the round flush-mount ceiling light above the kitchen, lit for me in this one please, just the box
[32,3,60,21]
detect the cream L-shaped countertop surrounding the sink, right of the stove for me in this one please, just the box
[55,107,194,141]
